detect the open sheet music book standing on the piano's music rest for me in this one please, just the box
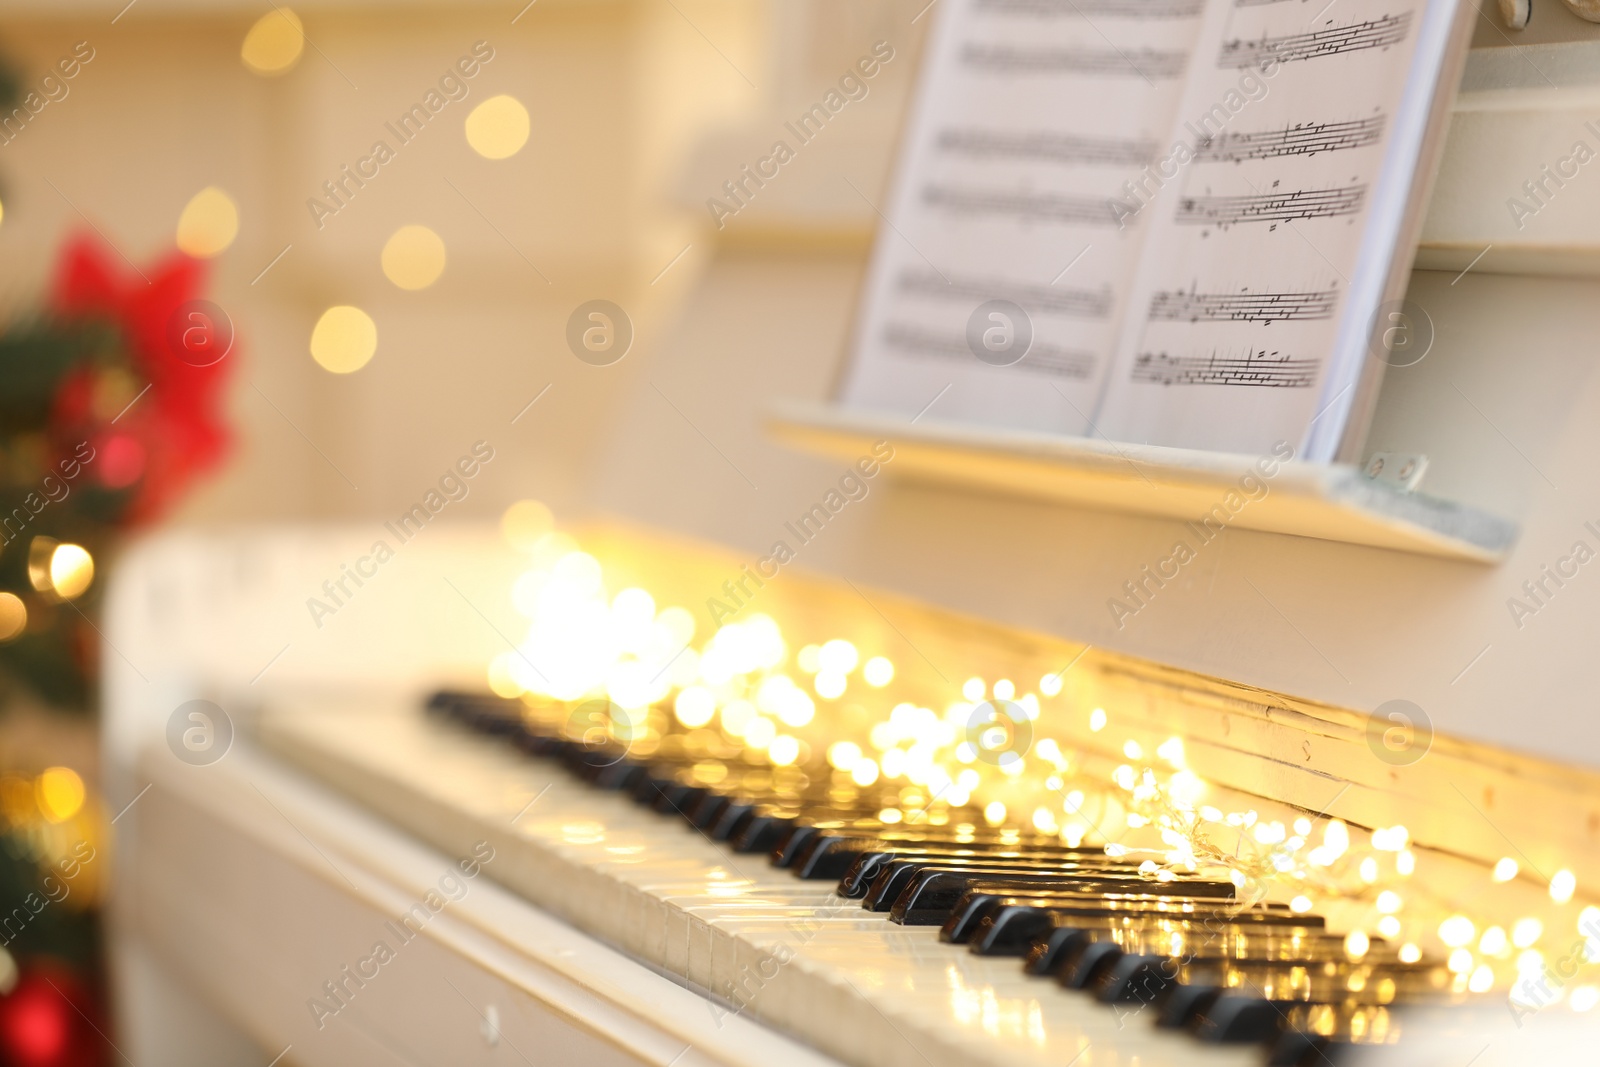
[842,0,1474,461]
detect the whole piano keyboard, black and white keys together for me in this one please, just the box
[262,694,1497,1067]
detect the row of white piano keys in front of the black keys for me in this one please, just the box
[264,709,1280,1067]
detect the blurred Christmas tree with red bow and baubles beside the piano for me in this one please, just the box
[0,45,234,1067]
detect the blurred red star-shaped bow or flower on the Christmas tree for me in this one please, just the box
[51,235,237,523]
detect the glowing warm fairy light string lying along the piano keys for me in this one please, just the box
[488,501,1600,1011]
